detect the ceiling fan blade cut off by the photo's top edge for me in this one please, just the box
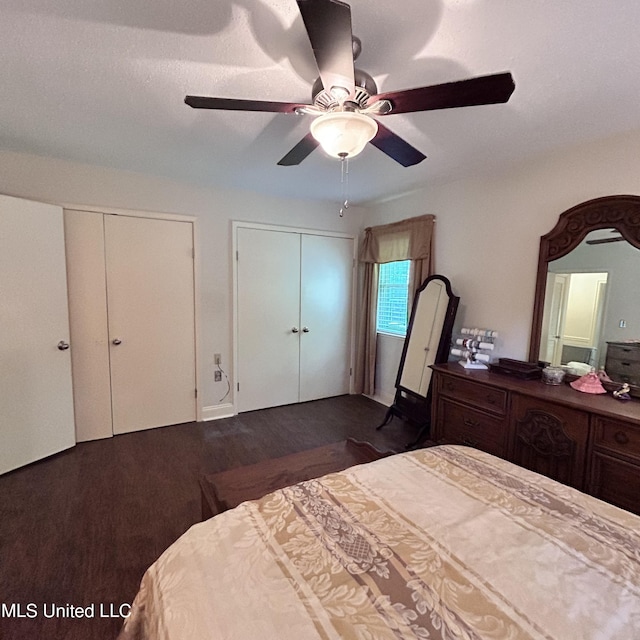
[297,0,354,93]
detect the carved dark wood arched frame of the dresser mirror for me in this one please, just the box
[529,195,640,384]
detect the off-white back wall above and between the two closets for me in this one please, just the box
[0,151,363,418]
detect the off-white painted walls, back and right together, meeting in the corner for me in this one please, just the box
[5,125,640,413]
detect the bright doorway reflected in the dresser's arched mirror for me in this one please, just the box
[541,272,608,367]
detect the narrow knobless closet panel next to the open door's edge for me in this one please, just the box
[64,211,113,442]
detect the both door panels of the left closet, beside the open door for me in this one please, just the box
[65,210,196,441]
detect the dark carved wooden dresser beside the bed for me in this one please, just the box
[431,362,640,514]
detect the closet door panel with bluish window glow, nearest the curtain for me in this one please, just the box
[300,235,353,402]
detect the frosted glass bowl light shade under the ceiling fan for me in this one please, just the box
[311,111,378,158]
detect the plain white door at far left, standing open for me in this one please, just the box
[0,196,75,473]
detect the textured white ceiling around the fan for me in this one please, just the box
[0,0,640,202]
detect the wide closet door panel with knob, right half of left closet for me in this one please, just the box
[105,215,196,434]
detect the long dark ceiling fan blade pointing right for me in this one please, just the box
[376,72,515,114]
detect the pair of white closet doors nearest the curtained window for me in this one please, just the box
[236,227,353,412]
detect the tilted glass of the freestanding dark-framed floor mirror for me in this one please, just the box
[400,280,449,396]
